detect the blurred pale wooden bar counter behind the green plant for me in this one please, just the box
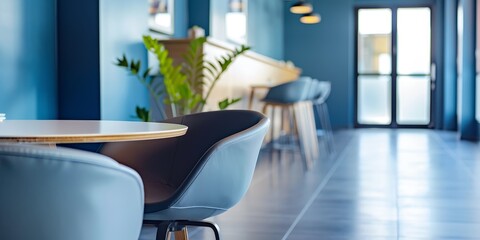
[160,38,301,111]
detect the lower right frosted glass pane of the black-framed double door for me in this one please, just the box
[397,76,430,125]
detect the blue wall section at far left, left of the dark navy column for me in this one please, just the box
[0,0,57,119]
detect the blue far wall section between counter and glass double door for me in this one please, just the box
[284,0,355,128]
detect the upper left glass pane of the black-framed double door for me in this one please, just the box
[358,9,392,74]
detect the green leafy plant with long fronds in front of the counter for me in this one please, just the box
[115,36,250,121]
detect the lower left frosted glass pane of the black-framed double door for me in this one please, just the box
[357,76,392,124]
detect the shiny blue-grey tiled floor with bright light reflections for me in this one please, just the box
[147,129,480,240]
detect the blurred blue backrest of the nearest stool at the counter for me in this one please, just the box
[263,76,312,103]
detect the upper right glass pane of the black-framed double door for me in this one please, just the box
[397,8,431,74]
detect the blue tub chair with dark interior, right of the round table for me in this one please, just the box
[101,110,269,239]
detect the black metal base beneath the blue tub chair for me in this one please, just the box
[143,220,220,240]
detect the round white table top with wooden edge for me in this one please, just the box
[0,120,187,143]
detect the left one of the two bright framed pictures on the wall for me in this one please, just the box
[148,0,175,35]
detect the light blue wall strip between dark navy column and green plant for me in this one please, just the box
[100,0,152,120]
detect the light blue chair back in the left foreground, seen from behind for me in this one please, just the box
[0,144,144,240]
